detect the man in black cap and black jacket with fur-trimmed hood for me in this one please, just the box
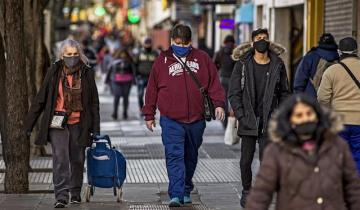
[229,29,290,207]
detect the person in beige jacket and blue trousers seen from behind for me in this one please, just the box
[318,37,360,174]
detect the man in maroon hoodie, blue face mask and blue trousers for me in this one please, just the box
[143,24,225,207]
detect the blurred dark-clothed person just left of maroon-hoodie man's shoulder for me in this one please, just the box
[136,38,158,111]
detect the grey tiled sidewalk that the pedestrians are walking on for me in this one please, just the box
[0,79,259,210]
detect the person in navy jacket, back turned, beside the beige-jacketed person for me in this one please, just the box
[294,33,339,98]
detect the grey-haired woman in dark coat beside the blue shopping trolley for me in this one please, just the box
[25,39,100,208]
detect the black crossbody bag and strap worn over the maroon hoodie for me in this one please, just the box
[173,54,216,121]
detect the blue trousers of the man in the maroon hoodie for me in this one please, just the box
[160,116,206,200]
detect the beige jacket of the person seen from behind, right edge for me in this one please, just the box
[318,57,360,125]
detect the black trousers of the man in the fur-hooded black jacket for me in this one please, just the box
[240,135,267,190]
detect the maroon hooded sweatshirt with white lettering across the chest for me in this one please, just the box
[142,48,225,123]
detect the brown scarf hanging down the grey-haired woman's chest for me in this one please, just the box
[61,63,83,115]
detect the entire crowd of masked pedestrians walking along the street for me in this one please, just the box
[25,24,360,210]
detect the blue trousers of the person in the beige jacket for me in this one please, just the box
[339,125,360,174]
